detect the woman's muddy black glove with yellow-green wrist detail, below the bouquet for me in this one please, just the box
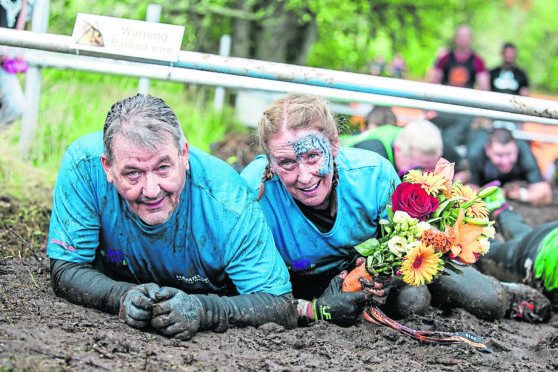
[313,273,371,327]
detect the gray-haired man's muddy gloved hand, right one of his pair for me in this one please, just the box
[151,287,205,340]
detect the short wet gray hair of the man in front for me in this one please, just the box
[103,94,186,164]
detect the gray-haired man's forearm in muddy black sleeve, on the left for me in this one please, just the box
[50,259,133,314]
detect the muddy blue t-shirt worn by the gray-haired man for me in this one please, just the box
[47,132,291,295]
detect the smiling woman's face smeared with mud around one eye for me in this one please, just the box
[268,128,338,209]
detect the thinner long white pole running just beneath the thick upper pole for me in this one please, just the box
[21,51,558,125]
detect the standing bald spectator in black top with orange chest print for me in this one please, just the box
[430,25,490,90]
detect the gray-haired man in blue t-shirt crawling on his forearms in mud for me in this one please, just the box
[47,94,298,339]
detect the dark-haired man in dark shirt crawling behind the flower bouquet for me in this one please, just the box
[467,128,552,205]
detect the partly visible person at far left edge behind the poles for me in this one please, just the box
[0,0,35,130]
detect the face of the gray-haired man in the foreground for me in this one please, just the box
[102,134,189,225]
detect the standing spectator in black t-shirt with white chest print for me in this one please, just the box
[490,43,529,96]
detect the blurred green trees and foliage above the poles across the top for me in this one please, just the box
[49,0,558,93]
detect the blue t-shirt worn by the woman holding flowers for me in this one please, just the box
[241,148,400,275]
